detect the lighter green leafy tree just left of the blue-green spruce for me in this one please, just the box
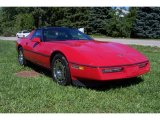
[105,8,136,37]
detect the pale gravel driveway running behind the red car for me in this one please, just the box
[0,36,160,47]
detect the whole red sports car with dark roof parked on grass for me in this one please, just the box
[16,27,150,85]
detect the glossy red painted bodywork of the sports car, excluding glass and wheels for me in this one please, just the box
[16,29,150,80]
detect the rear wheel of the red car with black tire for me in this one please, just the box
[18,47,27,66]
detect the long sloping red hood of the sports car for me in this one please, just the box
[51,40,148,67]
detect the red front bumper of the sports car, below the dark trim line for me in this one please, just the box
[69,61,150,81]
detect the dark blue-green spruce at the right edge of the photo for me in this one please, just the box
[132,7,160,38]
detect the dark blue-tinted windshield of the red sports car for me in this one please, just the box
[44,28,93,41]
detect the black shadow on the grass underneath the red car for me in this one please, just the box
[28,62,144,91]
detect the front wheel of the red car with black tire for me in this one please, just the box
[51,53,71,86]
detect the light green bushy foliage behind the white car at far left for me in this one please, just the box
[0,7,34,36]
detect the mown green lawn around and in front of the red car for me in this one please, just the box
[0,41,160,113]
